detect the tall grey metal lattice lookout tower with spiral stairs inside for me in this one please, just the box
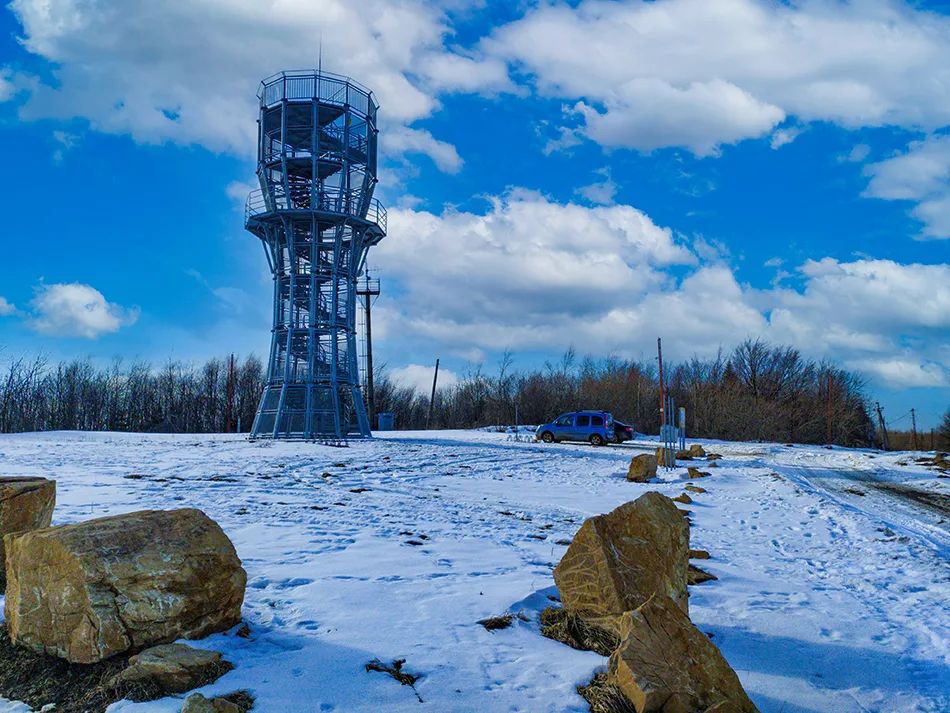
[245,70,386,440]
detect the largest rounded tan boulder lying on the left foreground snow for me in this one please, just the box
[6,509,247,663]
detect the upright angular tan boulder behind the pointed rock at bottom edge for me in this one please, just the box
[554,492,689,619]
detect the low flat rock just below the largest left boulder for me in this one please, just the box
[111,644,231,693]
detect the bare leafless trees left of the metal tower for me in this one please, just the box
[0,355,264,433]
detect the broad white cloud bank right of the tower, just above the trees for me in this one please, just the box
[372,191,950,386]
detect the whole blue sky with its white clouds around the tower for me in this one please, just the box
[0,0,950,428]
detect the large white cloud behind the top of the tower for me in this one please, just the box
[10,0,507,166]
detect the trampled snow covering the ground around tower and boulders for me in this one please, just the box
[0,431,950,713]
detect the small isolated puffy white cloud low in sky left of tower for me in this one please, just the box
[27,282,138,339]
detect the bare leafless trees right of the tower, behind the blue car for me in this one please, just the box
[375,340,876,445]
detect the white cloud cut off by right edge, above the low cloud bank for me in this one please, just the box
[864,135,950,239]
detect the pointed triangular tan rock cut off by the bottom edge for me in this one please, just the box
[607,593,758,713]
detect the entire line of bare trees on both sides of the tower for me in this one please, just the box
[0,340,932,448]
